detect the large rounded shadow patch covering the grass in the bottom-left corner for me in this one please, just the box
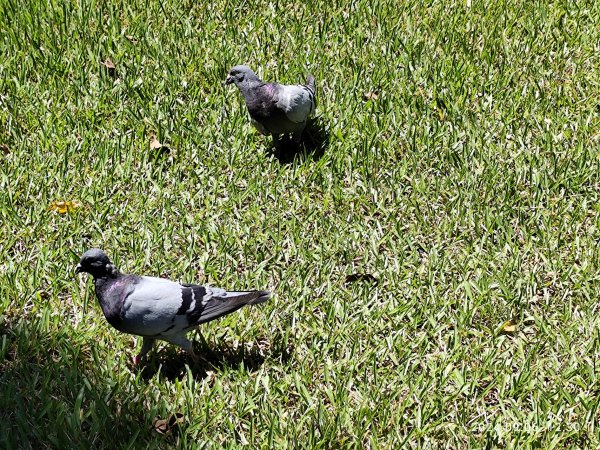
[0,320,159,448]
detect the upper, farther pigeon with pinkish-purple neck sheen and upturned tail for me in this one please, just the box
[225,66,317,143]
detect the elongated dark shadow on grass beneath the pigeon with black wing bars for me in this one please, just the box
[139,335,292,380]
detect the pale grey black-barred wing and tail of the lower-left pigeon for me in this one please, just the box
[119,277,270,338]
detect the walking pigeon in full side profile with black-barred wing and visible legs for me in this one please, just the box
[75,248,271,365]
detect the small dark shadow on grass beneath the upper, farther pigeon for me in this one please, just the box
[271,117,329,164]
